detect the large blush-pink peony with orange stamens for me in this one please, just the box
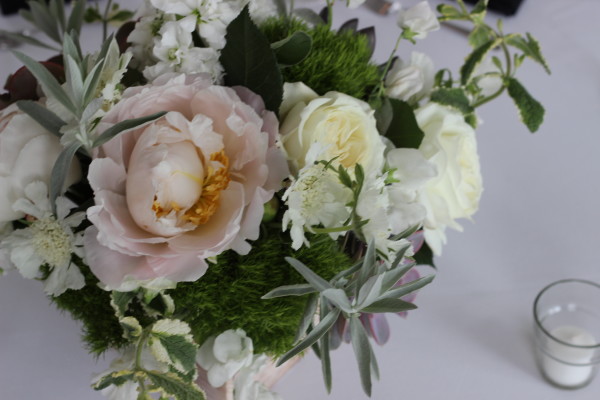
[85,75,289,290]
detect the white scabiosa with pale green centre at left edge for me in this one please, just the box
[1,181,85,296]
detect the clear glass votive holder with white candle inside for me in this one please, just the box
[533,279,600,389]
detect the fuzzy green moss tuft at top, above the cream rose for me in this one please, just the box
[260,19,379,98]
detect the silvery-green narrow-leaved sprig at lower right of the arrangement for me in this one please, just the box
[263,239,433,396]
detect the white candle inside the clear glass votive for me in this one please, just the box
[542,325,596,387]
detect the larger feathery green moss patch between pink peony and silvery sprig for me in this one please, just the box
[169,232,350,355]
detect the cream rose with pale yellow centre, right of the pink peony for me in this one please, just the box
[280,83,385,174]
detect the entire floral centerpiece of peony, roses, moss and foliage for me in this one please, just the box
[0,0,547,400]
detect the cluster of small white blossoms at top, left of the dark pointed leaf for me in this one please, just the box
[128,0,276,83]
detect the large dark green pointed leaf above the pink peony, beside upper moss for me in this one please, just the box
[219,6,283,114]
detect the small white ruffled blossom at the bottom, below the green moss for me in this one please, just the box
[196,329,254,387]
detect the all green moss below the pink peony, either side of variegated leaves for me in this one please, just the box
[53,231,351,355]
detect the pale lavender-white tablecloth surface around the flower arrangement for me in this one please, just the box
[0,0,600,400]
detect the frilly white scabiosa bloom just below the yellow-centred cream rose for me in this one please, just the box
[282,164,352,250]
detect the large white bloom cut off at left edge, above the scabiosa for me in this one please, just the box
[0,105,81,223]
